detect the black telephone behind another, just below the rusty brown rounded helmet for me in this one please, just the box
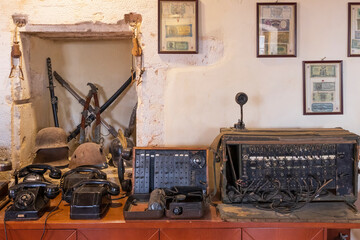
[60,167,106,203]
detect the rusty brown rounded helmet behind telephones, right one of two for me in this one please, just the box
[69,142,107,169]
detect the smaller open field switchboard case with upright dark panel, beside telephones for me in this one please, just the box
[124,147,208,220]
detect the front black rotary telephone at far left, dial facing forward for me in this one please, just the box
[5,181,60,220]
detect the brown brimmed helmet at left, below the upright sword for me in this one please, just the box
[33,127,69,167]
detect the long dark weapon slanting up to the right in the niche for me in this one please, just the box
[67,72,136,142]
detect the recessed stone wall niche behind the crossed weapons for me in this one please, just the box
[12,20,137,168]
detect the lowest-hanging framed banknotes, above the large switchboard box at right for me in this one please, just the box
[303,61,343,115]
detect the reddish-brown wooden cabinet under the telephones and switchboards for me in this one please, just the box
[0,196,360,240]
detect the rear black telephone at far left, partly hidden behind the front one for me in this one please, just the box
[15,164,61,184]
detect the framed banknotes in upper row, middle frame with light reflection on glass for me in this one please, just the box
[256,3,296,57]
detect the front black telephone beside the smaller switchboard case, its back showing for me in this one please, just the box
[70,179,120,219]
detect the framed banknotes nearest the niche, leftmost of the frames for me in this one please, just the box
[158,0,199,53]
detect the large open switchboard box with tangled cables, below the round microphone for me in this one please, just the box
[219,128,359,203]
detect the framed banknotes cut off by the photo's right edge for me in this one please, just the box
[348,2,360,57]
